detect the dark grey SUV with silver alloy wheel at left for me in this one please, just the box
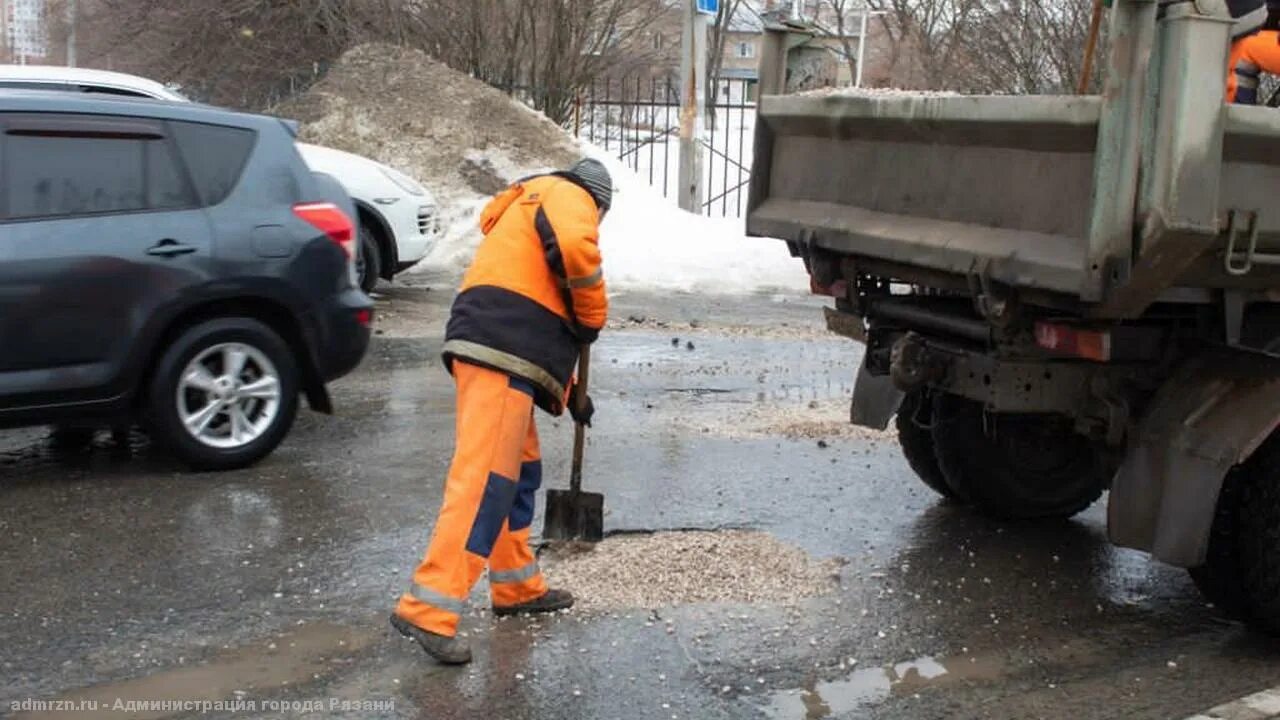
[0,91,372,469]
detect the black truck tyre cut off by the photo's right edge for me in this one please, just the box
[1190,433,1280,635]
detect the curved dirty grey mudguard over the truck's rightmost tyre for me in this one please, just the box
[1107,348,1280,568]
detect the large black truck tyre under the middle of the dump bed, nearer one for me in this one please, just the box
[933,393,1110,520]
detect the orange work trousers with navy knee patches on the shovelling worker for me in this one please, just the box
[396,360,547,637]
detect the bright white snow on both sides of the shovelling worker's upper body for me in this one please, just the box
[416,143,809,293]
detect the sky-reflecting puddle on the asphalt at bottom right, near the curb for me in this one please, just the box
[764,657,1004,720]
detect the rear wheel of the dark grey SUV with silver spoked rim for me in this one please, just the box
[148,318,298,470]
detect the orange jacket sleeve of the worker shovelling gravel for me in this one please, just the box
[543,184,609,331]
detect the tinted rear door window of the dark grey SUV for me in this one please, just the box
[0,120,198,219]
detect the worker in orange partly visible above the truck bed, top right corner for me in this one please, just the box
[1226,0,1280,105]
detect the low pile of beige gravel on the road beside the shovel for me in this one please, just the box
[541,530,840,611]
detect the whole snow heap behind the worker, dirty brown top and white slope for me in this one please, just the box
[281,44,809,293]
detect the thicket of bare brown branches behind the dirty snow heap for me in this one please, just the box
[51,0,666,120]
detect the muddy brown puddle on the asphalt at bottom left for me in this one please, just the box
[13,623,381,720]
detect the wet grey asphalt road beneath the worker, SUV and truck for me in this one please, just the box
[0,278,1280,720]
